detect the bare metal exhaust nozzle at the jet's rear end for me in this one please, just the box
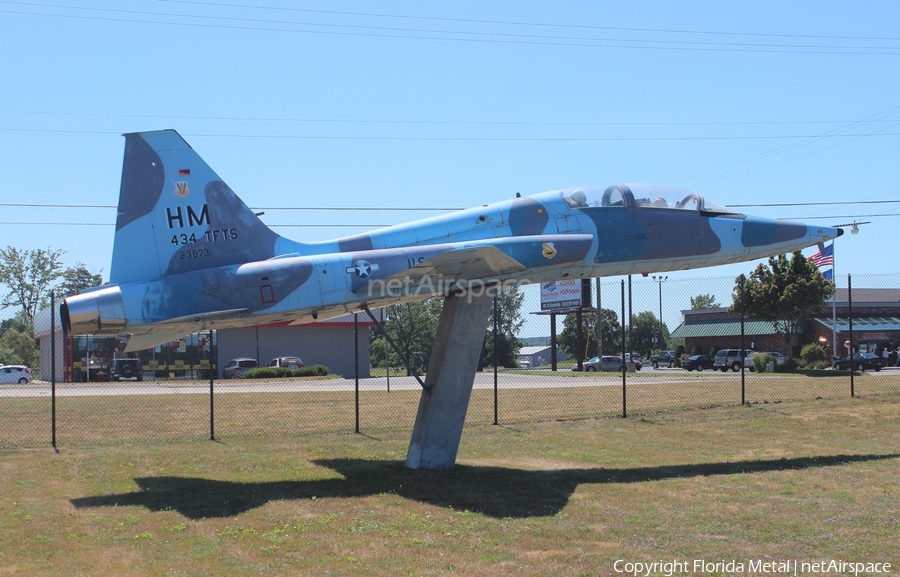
[59,286,128,335]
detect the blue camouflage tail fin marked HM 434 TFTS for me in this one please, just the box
[110,130,290,284]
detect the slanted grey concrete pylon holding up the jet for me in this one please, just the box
[406,286,493,471]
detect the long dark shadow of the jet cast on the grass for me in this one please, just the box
[71,453,900,519]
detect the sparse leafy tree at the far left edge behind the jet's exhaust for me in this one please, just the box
[0,246,66,323]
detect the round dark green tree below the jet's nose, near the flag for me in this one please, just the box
[731,251,834,351]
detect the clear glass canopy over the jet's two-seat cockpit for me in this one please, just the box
[562,184,740,214]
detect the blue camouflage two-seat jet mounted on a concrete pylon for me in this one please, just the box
[61,130,843,468]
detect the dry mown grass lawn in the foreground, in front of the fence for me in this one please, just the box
[0,394,900,576]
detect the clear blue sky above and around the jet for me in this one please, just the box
[0,0,900,328]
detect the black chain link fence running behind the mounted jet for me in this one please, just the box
[7,273,900,449]
